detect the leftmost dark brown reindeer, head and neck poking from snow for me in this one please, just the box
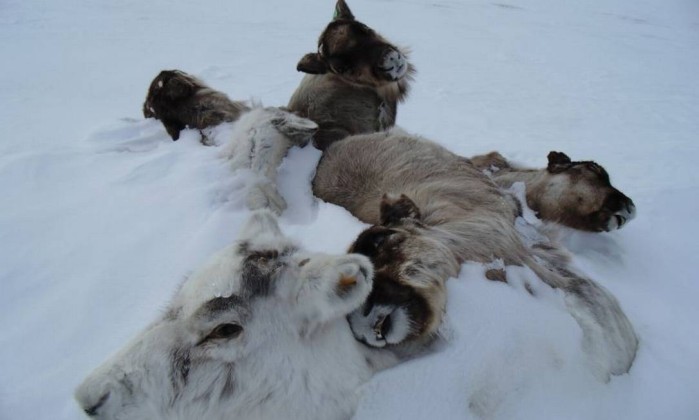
[143,70,250,144]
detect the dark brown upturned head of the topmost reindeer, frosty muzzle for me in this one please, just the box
[296,0,415,87]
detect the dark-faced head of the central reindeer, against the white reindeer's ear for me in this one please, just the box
[349,195,458,347]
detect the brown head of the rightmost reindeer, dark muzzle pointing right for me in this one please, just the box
[527,152,636,232]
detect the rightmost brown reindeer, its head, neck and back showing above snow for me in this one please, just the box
[471,152,636,232]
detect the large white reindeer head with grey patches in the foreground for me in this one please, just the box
[76,211,373,419]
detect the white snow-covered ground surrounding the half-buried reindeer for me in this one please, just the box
[0,0,699,419]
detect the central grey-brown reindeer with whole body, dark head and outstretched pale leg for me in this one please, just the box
[313,130,638,380]
